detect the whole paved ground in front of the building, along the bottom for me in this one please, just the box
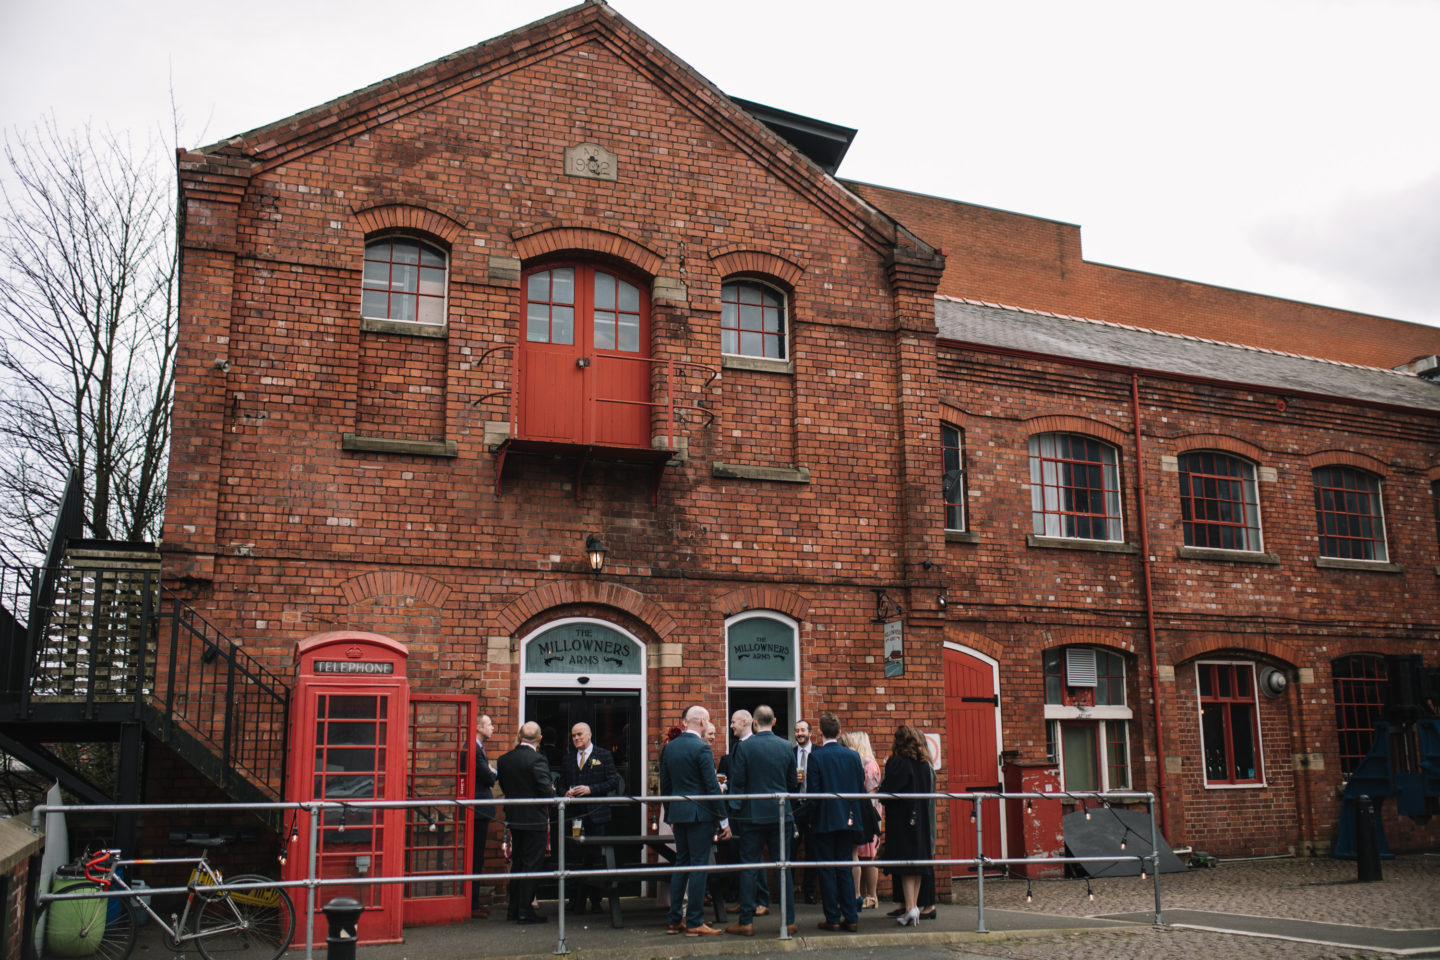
[135,855,1440,960]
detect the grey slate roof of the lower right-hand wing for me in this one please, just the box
[935,296,1440,410]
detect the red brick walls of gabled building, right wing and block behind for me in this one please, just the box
[151,4,1440,909]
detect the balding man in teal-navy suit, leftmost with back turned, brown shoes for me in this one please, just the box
[660,707,730,937]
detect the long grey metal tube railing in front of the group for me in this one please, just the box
[32,792,1164,960]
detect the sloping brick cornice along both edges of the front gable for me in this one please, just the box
[183,0,940,261]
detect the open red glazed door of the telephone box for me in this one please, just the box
[405,694,475,927]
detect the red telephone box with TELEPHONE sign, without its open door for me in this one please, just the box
[284,630,409,943]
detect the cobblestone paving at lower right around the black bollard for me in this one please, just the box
[955,855,1440,960]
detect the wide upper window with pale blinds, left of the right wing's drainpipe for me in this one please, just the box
[1030,433,1120,541]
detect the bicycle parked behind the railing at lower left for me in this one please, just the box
[33,838,295,960]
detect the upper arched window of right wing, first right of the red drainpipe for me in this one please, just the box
[1179,450,1261,551]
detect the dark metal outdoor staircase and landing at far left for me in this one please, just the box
[0,481,289,846]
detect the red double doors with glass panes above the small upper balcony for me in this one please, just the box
[517,265,651,449]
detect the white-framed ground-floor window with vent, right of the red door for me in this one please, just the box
[1041,646,1133,792]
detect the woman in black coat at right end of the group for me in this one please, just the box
[878,724,935,927]
